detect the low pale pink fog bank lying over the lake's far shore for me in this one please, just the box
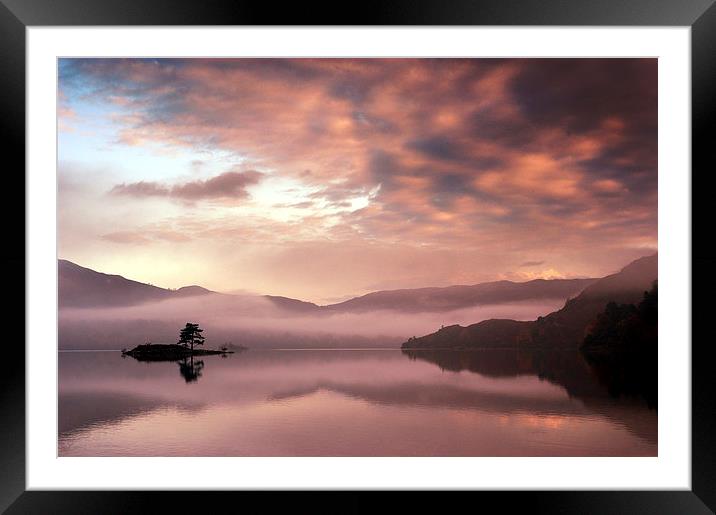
[59,295,564,349]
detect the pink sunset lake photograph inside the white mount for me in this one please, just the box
[58,56,656,458]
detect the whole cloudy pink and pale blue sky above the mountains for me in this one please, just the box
[57,58,657,303]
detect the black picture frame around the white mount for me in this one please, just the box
[0,0,716,514]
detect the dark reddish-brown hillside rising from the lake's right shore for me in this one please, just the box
[403,254,658,349]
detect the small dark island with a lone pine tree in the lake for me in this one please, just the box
[122,322,246,361]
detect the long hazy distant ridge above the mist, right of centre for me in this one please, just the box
[325,279,596,313]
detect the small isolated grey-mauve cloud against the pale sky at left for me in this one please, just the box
[110,170,263,201]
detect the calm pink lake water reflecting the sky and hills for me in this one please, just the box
[58,350,657,456]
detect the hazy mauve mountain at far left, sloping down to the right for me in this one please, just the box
[57,259,214,308]
